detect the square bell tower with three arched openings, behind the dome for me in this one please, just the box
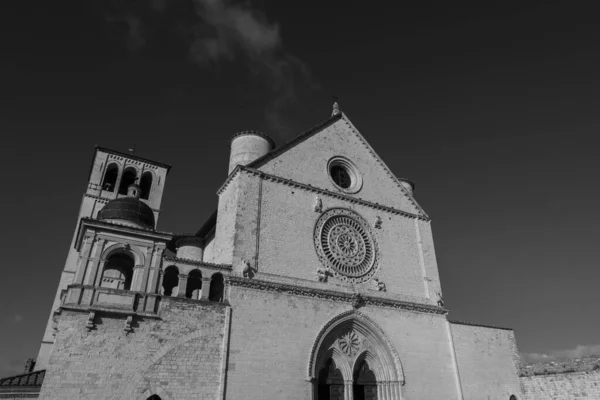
[36,146,171,369]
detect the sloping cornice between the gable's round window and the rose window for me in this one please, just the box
[223,165,431,221]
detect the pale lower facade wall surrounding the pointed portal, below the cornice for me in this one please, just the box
[227,284,459,400]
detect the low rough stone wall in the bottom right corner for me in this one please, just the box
[521,356,600,400]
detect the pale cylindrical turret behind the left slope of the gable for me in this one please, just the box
[227,131,275,174]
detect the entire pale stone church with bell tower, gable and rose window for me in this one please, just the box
[5,107,523,400]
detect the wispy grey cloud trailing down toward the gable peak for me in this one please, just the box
[190,0,317,135]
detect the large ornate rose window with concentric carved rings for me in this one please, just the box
[314,208,378,283]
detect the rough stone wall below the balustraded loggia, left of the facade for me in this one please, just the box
[40,297,229,400]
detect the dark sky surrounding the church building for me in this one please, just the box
[0,0,600,375]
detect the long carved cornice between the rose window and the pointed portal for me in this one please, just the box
[228,276,448,315]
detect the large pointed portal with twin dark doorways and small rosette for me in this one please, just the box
[309,311,404,400]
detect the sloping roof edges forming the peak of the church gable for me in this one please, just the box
[247,112,429,218]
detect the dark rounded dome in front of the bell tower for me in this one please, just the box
[98,197,154,229]
